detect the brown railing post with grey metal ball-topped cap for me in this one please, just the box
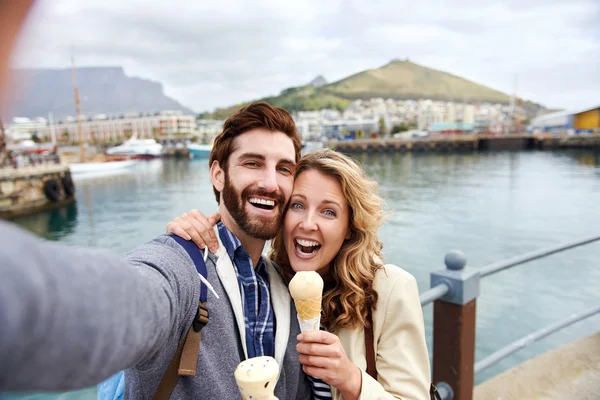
[431,251,480,400]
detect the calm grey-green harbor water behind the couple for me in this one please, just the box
[0,151,600,400]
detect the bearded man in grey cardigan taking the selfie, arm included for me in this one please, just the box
[0,0,311,399]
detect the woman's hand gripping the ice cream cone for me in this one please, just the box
[296,331,362,400]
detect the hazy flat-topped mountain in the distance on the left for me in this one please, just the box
[5,67,193,119]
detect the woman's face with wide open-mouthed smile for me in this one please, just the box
[283,170,350,275]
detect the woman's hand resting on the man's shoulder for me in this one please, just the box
[167,210,221,253]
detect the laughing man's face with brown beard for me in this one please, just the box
[217,129,296,240]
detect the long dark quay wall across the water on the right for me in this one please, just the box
[325,135,600,154]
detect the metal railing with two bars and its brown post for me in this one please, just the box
[419,235,600,400]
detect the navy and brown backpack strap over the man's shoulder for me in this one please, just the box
[153,235,209,400]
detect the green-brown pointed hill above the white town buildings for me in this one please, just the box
[206,60,510,119]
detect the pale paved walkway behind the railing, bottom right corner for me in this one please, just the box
[473,333,600,400]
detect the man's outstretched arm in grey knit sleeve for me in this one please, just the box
[0,222,199,392]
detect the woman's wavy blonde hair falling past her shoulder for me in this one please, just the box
[269,149,384,332]
